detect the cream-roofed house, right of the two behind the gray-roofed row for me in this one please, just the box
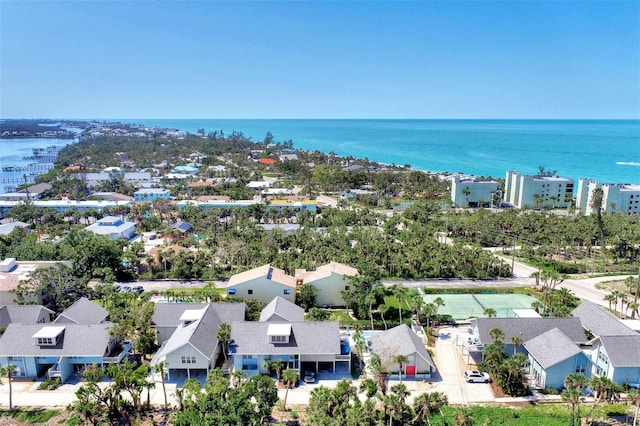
[295,262,358,307]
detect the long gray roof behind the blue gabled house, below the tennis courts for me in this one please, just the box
[476,317,587,344]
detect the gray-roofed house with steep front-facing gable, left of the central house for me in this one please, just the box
[151,303,246,378]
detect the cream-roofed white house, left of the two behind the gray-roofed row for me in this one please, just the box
[226,264,296,303]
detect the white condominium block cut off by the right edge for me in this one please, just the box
[576,179,640,216]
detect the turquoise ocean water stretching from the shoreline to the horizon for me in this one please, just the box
[120,119,640,183]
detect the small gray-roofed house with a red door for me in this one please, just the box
[367,324,436,379]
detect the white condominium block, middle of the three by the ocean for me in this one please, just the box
[504,171,573,209]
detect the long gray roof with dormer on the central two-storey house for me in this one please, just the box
[229,321,340,355]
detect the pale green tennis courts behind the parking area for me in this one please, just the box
[423,294,536,320]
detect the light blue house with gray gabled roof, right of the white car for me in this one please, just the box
[522,328,590,389]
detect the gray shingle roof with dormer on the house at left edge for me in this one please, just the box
[0,322,112,357]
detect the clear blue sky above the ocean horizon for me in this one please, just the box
[0,0,640,118]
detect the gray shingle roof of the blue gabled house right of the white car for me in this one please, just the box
[523,328,582,368]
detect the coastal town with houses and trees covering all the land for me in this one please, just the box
[0,120,640,425]
